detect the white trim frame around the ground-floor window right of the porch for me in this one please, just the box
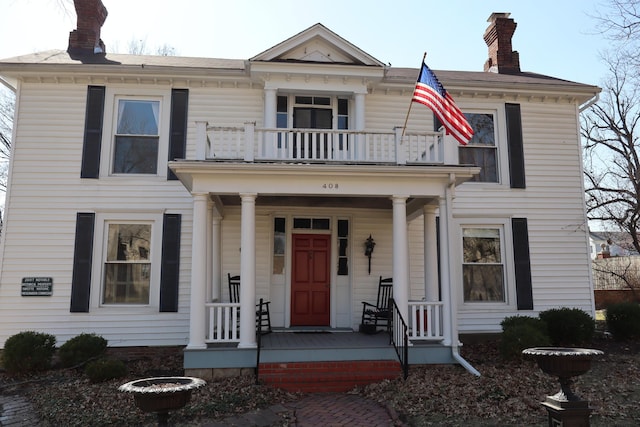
[454,218,516,311]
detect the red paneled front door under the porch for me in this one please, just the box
[291,234,331,326]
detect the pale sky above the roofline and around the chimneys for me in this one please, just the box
[0,0,606,84]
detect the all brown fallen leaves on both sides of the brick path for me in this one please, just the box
[2,341,640,426]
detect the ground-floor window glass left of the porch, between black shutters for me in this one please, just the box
[102,223,151,304]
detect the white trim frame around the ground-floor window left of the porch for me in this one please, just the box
[90,211,163,313]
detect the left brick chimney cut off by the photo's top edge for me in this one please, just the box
[67,0,107,55]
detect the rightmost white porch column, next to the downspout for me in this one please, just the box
[440,188,458,345]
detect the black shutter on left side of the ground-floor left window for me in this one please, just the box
[70,212,95,313]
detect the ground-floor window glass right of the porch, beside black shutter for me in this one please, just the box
[462,227,506,302]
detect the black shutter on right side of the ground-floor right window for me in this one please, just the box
[511,218,533,310]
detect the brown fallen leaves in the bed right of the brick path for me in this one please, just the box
[363,341,640,426]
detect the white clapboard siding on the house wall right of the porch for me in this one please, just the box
[454,101,593,332]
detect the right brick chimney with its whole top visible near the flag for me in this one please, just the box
[483,13,520,74]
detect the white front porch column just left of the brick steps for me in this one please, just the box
[238,193,257,348]
